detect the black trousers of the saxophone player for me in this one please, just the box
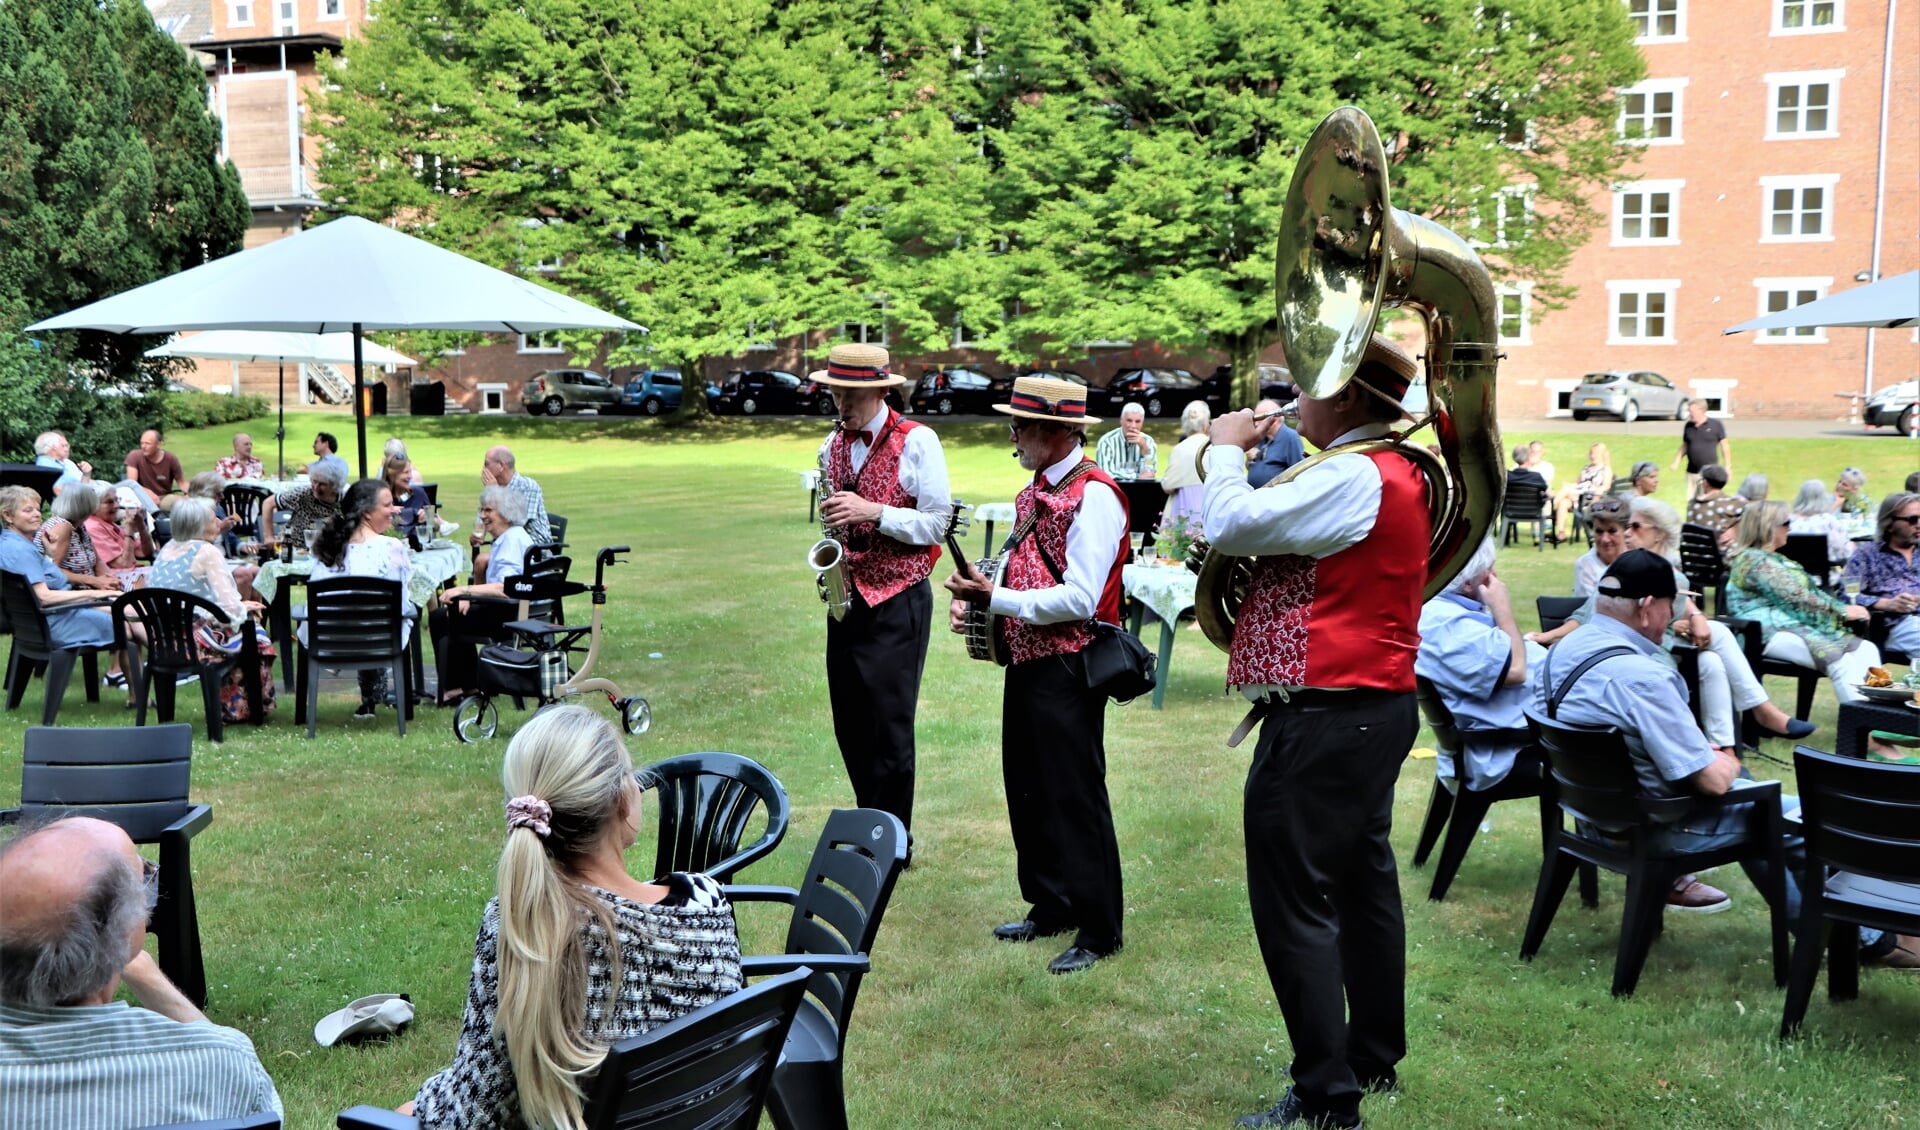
[828,581,933,829]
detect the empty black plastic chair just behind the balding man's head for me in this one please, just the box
[0,721,213,1005]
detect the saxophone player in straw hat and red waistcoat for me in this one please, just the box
[812,345,952,842]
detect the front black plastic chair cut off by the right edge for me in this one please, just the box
[1780,746,1920,1040]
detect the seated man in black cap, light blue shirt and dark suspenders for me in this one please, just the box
[1526,544,1920,969]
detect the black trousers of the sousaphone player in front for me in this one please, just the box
[1242,691,1419,1115]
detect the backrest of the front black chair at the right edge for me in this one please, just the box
[1793,746,1920,883]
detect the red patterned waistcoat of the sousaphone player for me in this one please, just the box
[1227,451,1430,691]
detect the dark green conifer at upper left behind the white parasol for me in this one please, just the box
[0,0,248,378]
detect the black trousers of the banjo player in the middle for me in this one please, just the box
[1000,654,1121,953]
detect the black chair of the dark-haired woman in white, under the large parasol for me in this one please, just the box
[294,577,413,739]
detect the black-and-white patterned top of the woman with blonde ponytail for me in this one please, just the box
[415,871,741,1130]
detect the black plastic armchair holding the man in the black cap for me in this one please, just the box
[1521,718,1788,996]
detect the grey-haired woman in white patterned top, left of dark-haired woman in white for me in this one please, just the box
[146,495,275,721]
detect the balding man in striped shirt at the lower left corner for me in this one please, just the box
[0,817,280,1130]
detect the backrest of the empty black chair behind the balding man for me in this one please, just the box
[19,721,194,844]
